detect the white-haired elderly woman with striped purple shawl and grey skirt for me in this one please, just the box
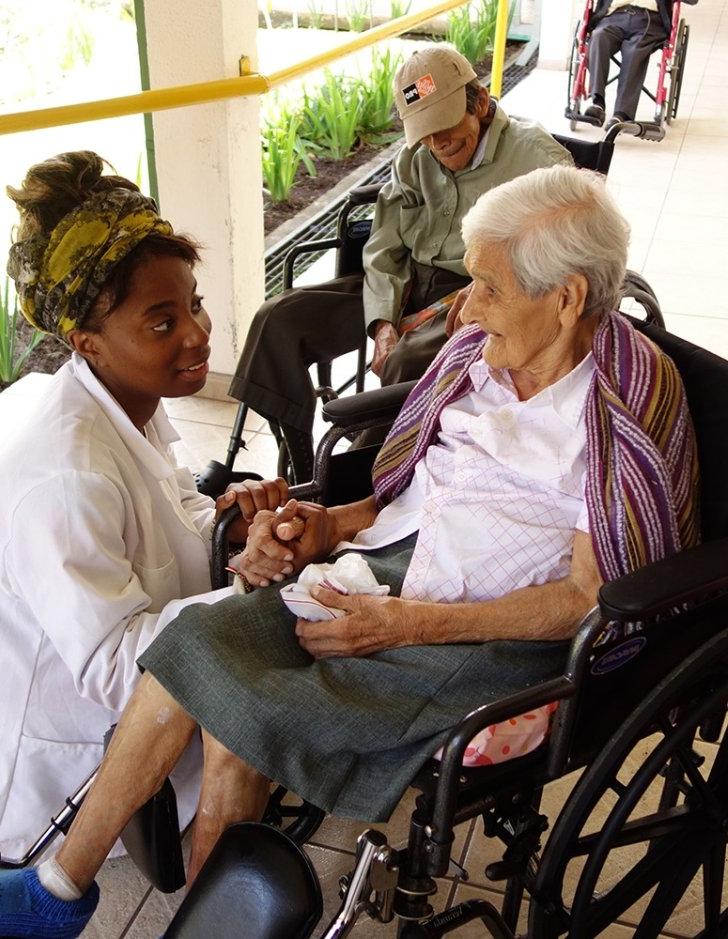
[0,167,697,936]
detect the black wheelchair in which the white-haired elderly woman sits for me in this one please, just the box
[159,312,728,939]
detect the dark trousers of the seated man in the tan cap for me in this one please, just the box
[230,265,469,479]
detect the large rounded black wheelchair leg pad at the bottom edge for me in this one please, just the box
[165,822,323,939]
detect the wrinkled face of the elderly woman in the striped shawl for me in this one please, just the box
[460,242,562,370]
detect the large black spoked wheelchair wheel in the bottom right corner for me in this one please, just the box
[528,647,728,939]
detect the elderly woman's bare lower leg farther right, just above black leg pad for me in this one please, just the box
[187,730,270,887]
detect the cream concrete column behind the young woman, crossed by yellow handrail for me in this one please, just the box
[144,0,264,397]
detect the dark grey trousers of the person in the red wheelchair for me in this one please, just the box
[589,7,665,120]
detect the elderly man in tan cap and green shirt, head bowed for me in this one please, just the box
[230,45,571,482]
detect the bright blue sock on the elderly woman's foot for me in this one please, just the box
[0,867,99,939]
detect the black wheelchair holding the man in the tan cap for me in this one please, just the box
[198,122,662,496]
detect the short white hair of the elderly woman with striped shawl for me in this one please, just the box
[463,166,629,314]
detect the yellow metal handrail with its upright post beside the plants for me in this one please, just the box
[0,0,508,135]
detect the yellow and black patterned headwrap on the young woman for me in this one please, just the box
[8,189,173,339]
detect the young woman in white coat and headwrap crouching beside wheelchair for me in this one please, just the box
[0,152,287,857]
